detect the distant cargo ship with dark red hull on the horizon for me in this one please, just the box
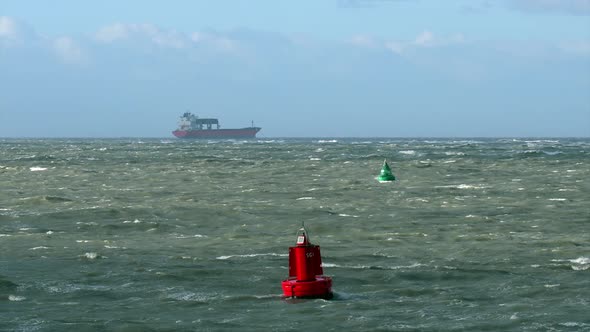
[172,112,262,139]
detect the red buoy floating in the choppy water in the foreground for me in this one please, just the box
[282,227,332,299]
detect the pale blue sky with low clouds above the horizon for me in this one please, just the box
[0,0,590,138]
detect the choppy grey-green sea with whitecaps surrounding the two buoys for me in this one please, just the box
[0,138,590,332]
